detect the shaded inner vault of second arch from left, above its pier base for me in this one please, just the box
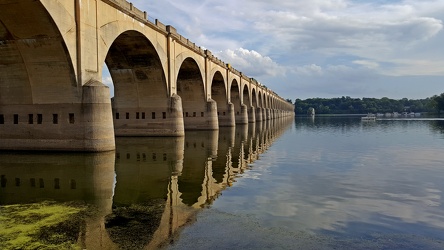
[105,31,168,109]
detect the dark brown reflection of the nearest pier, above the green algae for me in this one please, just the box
[0,152,115,249]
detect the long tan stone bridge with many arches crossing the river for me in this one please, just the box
[0,0,294,151]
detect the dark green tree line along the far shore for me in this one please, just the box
[287,93,444,115]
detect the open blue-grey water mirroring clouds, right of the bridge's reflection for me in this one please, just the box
[166,117,444,249]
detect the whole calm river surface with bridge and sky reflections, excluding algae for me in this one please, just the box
[0,118,444,249]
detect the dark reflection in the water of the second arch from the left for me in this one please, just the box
[105,137,184,249]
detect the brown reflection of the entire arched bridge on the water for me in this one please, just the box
[0,118,292,249]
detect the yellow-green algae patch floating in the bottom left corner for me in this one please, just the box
[0,202,86,249]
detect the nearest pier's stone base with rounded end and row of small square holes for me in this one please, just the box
[0,81,115,152]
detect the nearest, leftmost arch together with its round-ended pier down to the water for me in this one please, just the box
[0,0,115,151]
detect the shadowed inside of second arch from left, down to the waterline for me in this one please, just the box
[105,30,183,136]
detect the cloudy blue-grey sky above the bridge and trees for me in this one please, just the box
[106,0,444,101]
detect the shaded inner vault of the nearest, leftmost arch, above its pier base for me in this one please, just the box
[0,1,77,105]
